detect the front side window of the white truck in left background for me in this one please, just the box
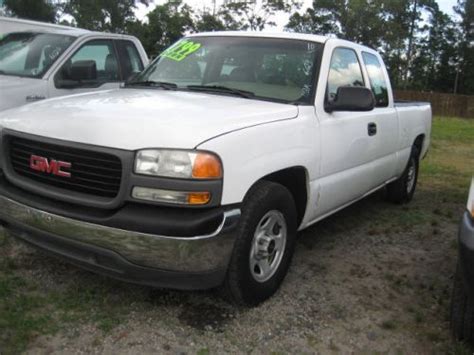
[55,40,120,88]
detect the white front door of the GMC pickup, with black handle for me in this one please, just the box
[315,43,376,216]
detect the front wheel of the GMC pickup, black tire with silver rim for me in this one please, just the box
[223,181,297,306]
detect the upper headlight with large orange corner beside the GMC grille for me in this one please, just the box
[135,149,222,179]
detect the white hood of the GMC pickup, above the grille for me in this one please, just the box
[0,89,298,150]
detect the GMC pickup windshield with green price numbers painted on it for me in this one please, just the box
[129,36,322,104]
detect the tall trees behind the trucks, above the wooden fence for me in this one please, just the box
[4,0,474,94]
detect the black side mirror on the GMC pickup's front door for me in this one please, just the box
[324,86,375,112]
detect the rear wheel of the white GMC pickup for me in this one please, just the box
[387,146,420,204]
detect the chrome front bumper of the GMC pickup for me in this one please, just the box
[0,196,240,289]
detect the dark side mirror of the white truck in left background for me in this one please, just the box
[56,60,97,89]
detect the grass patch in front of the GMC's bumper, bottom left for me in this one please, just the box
[0,248,135,355]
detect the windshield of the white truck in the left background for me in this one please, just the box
[0,32,76,78]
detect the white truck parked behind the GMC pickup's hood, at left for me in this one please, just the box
[0,17,148,111]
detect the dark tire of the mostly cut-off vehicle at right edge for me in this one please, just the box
[451,264,474,345]
